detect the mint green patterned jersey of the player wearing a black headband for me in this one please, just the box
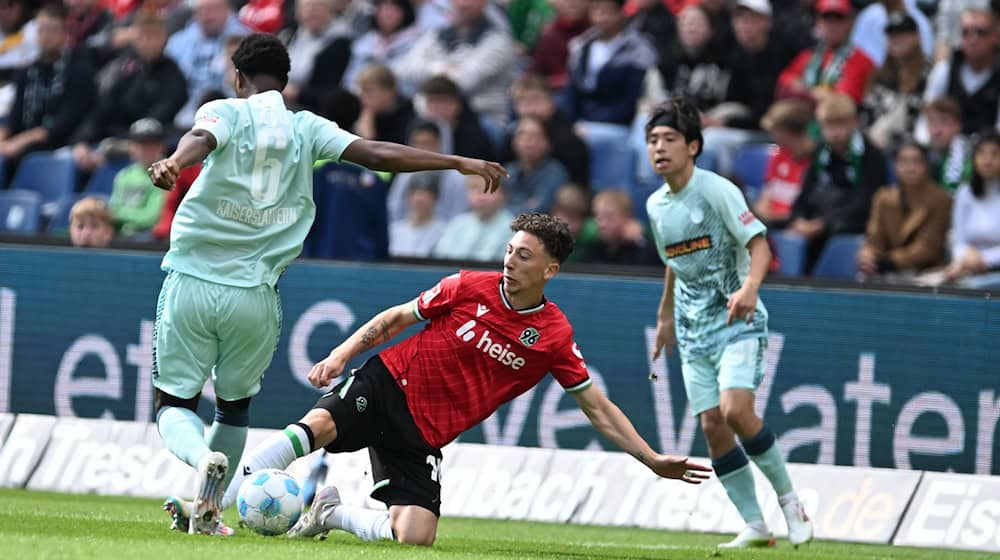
[646,167,767,357]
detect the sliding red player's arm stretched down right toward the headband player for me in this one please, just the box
[573,385,712,484]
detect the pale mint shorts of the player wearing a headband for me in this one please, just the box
[681,338,767,416]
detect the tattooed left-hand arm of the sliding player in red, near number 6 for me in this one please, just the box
[309,301,420,388]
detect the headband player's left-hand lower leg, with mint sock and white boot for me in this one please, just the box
[699,407,775,548]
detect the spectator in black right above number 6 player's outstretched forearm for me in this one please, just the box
[420,76,496,160]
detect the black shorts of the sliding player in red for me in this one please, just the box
[313,356,441,517]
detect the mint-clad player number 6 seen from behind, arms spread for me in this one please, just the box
[149,34,506,534]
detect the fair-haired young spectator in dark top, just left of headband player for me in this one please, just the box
[576,189,659,265]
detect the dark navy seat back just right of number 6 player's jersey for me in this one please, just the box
[305,163,389,261]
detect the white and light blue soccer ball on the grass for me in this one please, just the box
[236,469,302,537]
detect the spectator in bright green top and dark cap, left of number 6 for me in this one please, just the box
[111,119,167,241]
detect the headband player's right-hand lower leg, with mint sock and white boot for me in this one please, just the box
[721,389,813,547]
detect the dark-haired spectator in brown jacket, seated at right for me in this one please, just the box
[858,142,951,279]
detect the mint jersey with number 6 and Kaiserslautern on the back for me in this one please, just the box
[162,91,358,288]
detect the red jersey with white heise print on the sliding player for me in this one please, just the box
[379,271,591,447]
